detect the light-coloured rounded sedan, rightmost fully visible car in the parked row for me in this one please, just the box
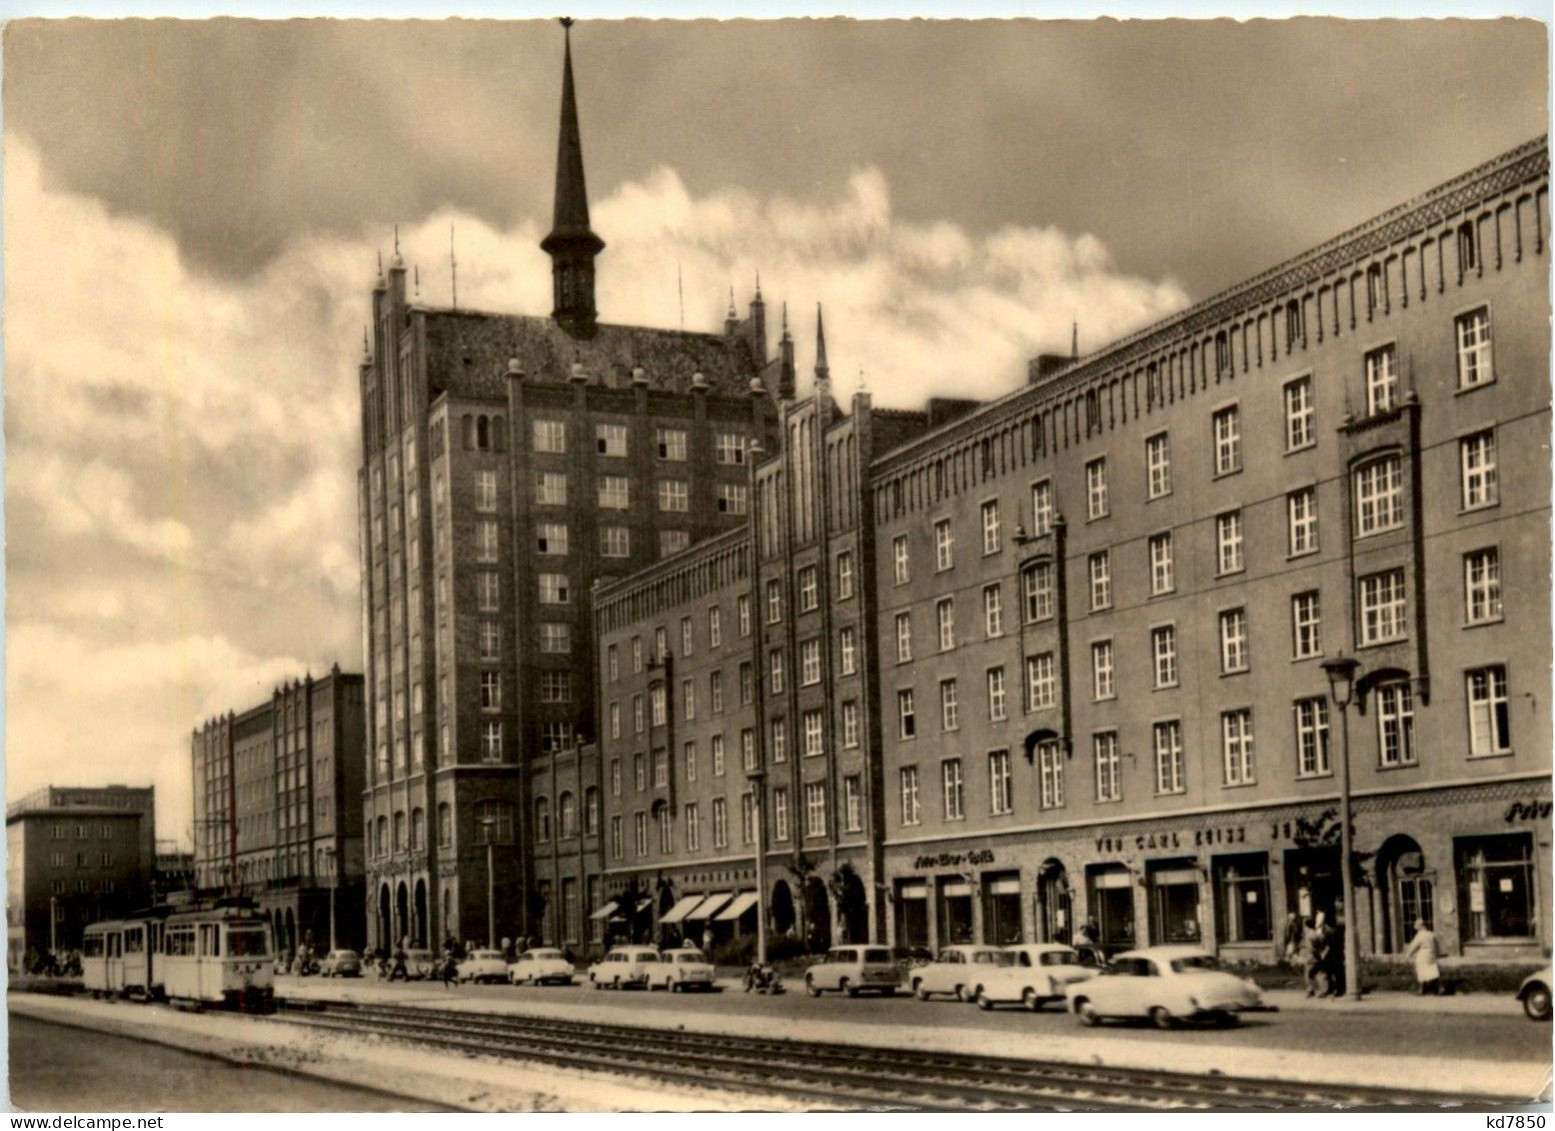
[1064,946,1267,1028]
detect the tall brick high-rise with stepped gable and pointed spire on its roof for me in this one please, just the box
[359,22,793,946]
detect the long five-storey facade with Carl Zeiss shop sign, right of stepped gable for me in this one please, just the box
[871,140,1550,960]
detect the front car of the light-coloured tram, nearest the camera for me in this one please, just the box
[159,905,275,1013]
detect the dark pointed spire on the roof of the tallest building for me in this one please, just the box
[540,19,605,338]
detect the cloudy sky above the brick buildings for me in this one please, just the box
[3,20,1547,837]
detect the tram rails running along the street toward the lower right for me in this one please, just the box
[278,1002,1513,1111]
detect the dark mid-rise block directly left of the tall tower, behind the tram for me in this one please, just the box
[190,667,367,951]
